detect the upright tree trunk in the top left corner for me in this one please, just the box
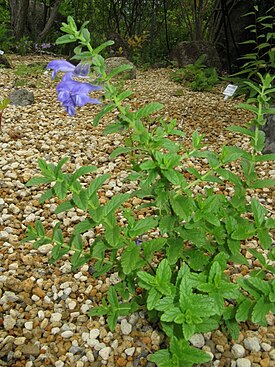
[9,0,29,41]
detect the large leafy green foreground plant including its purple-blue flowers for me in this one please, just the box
[25,18,275,367]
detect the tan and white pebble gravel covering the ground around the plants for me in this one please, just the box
[0,56,275,367]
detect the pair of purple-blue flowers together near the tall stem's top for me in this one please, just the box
[47,60,102,116]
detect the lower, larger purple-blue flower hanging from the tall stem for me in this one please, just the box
[56,72,102,116]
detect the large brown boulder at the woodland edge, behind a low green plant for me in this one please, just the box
[170,41,221,70]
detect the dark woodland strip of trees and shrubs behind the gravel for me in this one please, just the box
[0,0,273,71]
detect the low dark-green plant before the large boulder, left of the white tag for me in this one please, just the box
[171,55,219,91]
